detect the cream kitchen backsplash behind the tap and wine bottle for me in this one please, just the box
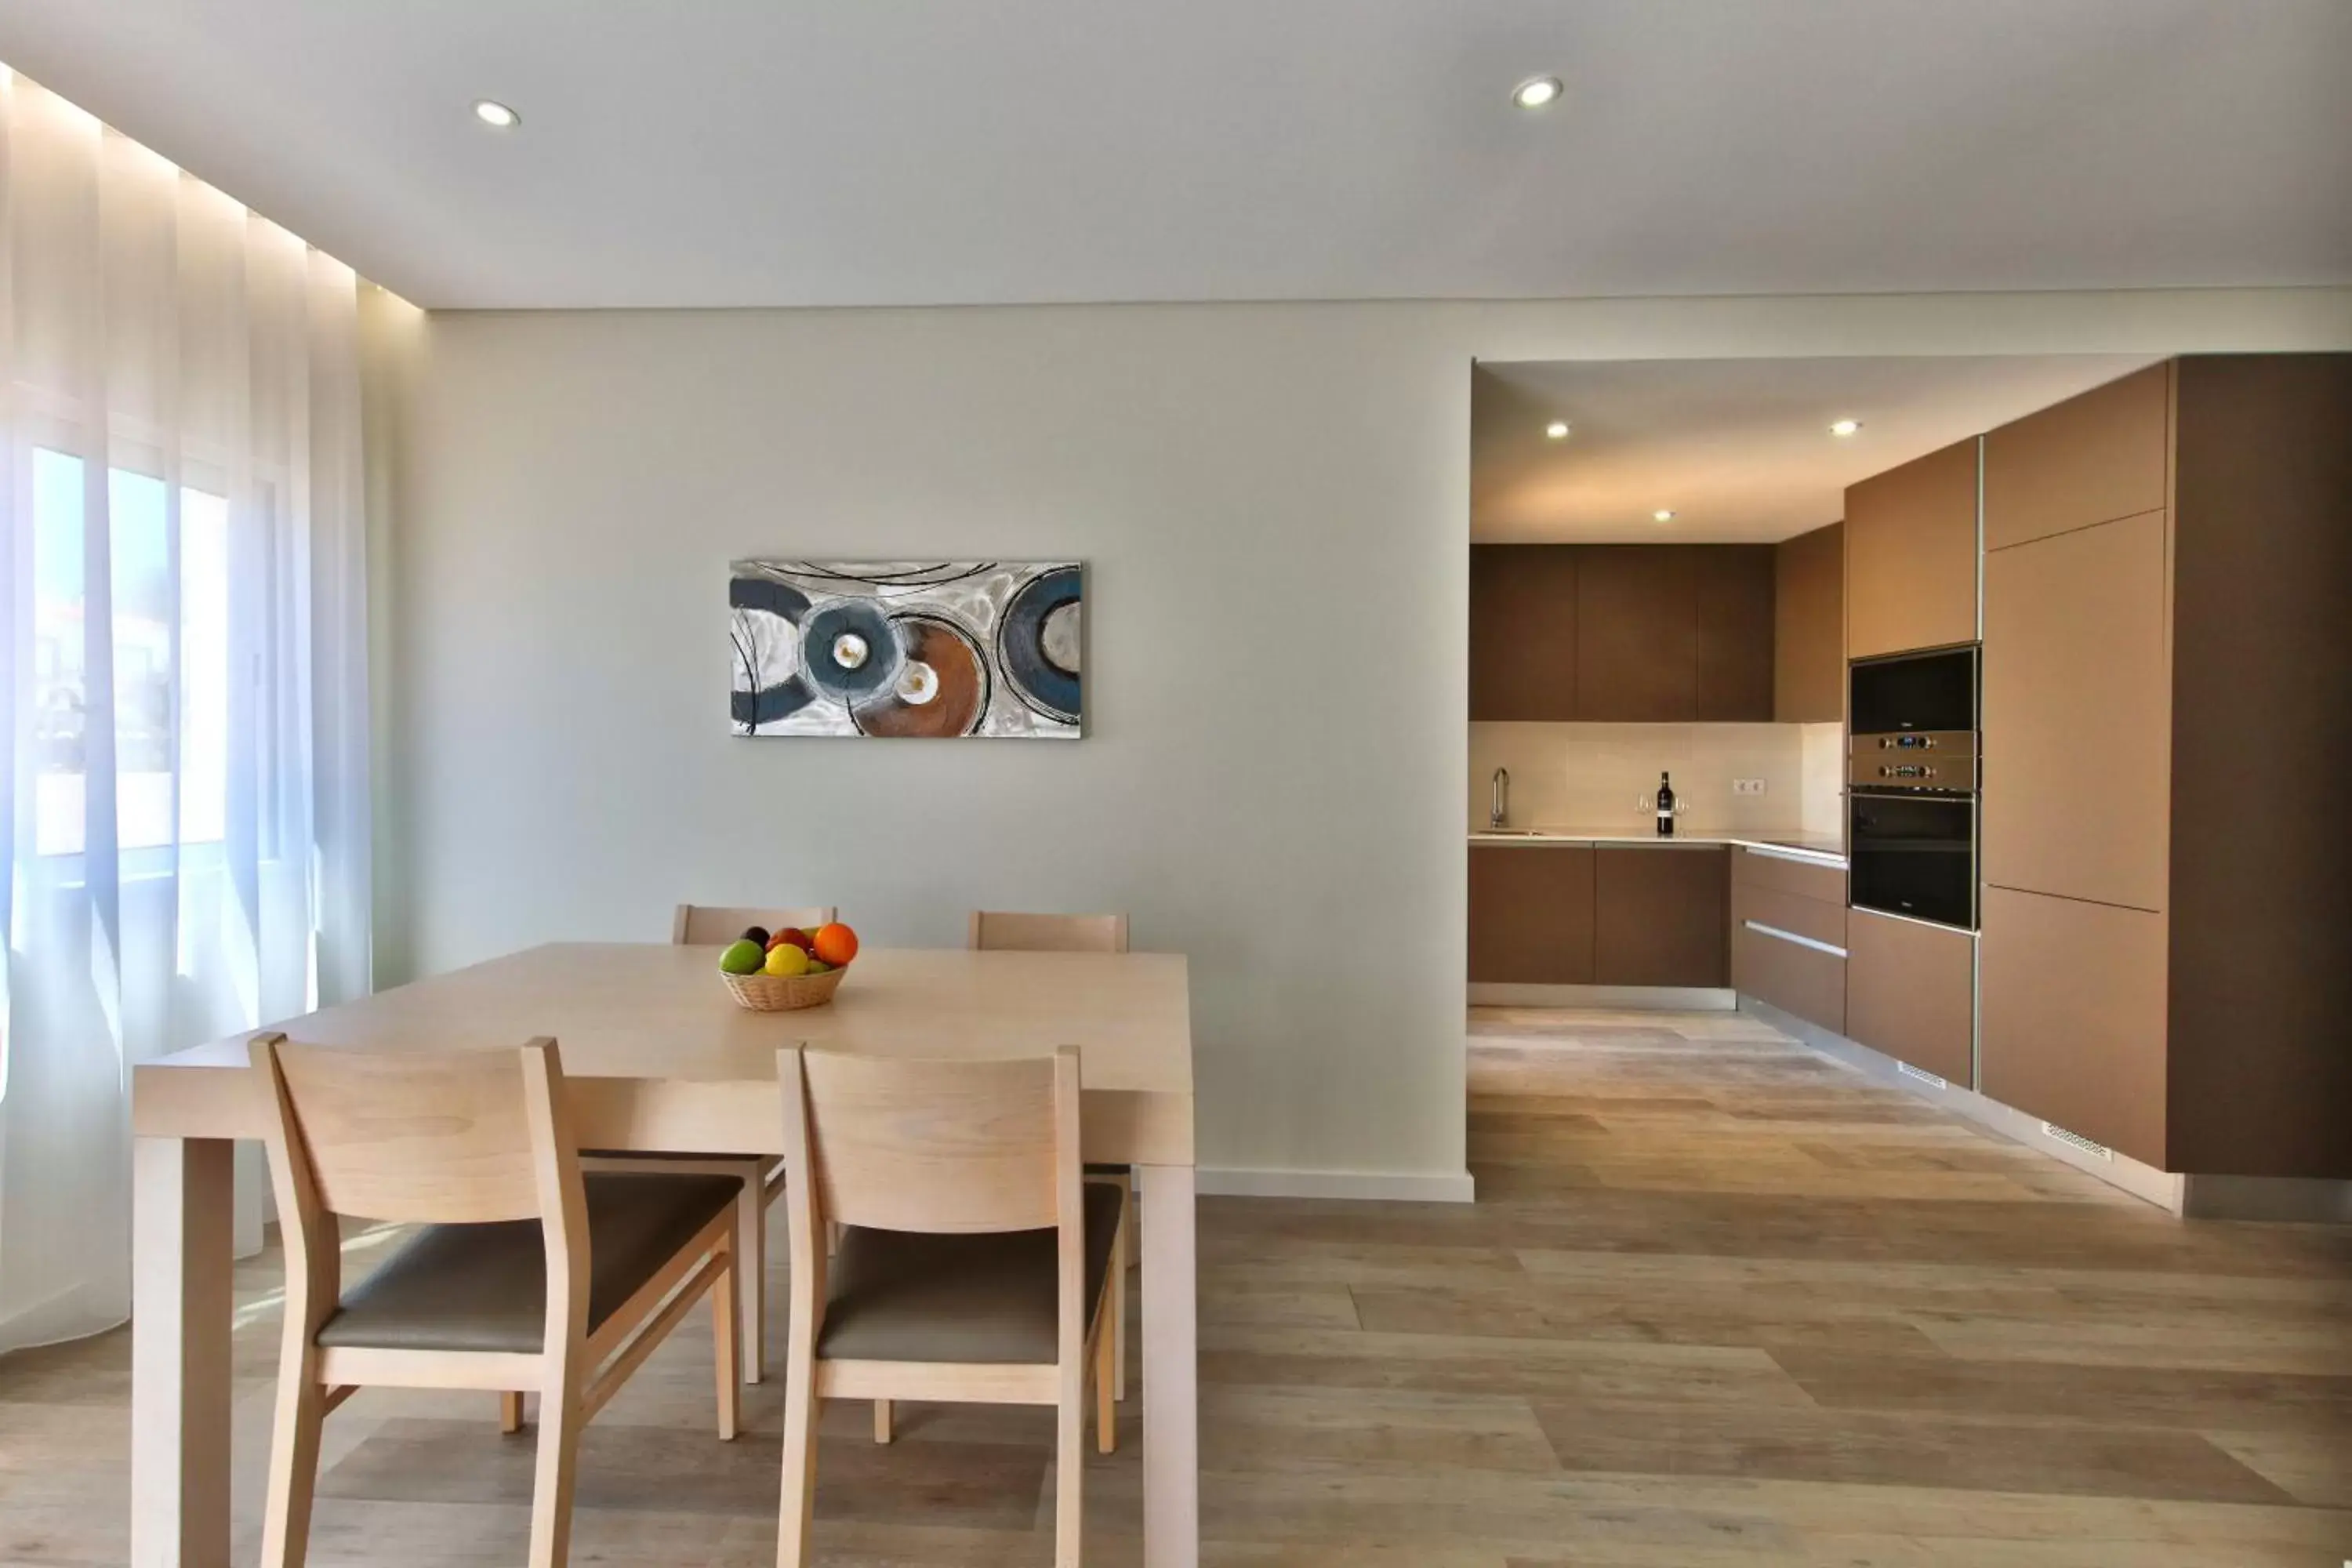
[1470,724,1844,832]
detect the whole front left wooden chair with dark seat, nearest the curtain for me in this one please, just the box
[249,1034,741,1568]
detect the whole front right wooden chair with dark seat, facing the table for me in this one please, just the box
[776,1046,1120,1568]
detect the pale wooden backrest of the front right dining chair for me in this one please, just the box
[776,1046,1080,1234]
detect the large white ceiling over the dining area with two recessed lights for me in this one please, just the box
[0,0,2352,306]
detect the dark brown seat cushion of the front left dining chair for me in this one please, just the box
[318,1173,743,1354]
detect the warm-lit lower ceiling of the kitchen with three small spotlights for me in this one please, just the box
[1470,355,2147,543]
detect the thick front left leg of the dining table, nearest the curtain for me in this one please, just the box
[132,1138,238,1568]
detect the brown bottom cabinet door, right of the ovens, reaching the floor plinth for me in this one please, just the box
[1983,886,2169,1171]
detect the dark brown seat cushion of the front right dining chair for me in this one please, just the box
[816,1185,1120,1366]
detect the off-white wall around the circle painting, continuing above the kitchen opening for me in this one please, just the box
[379,292,2352,1189]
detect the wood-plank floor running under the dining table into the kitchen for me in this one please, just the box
[0,1011,2352,1568]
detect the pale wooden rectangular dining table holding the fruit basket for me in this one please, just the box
[132,942,1200,1568]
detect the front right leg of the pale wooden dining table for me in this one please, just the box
[1138,1166,1200,1568]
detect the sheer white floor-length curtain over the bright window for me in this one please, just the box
[0,78,369,1349]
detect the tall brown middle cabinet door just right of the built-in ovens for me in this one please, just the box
[1983,513,2171,909]
